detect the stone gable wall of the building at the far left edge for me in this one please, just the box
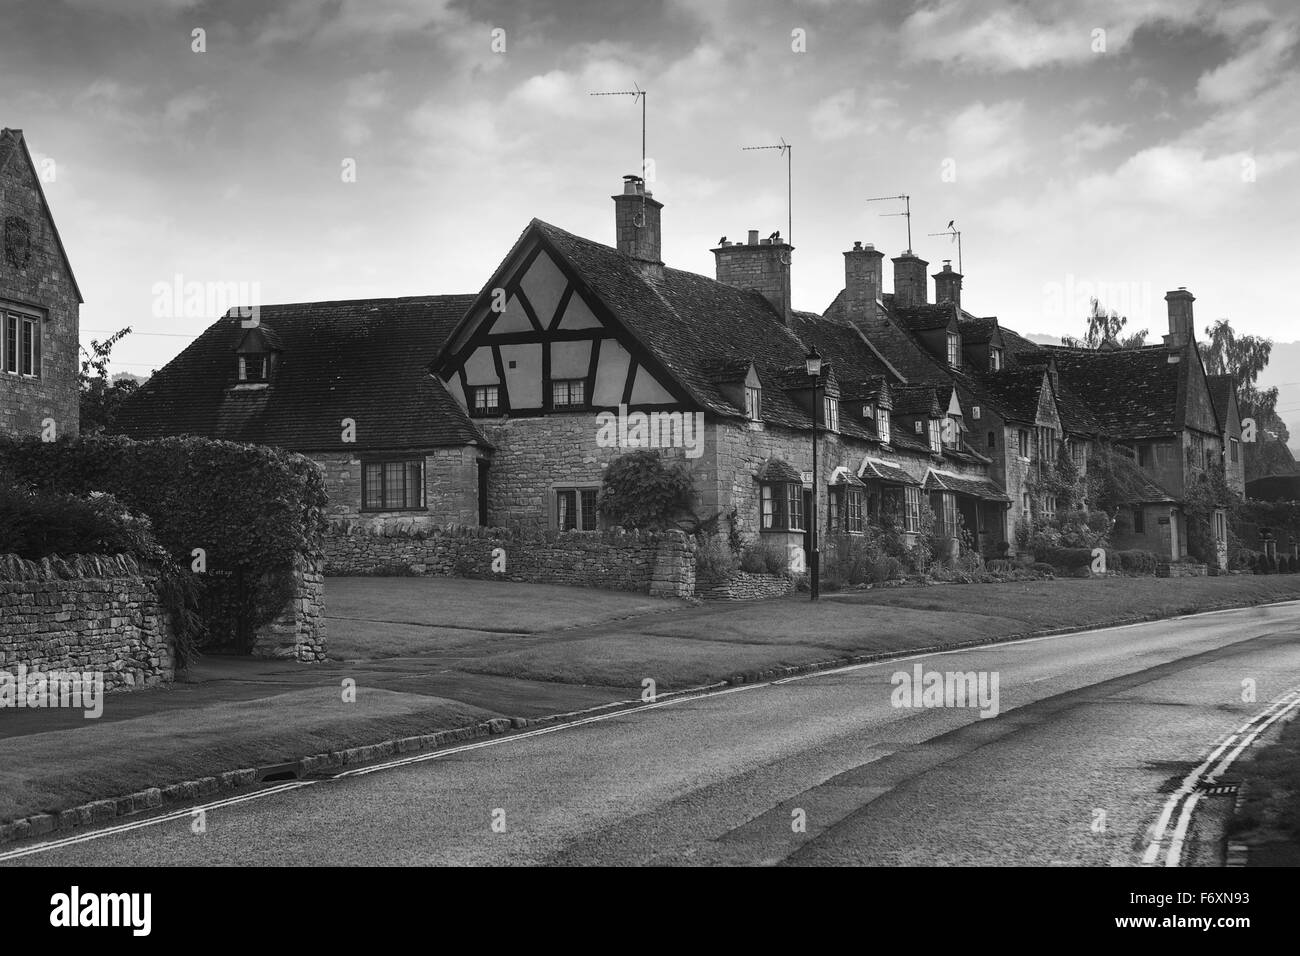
[0,128,81,437]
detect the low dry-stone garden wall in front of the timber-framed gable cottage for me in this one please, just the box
[325,522,696,597]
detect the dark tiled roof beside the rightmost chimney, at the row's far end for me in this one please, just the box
[1045,345,1188,440]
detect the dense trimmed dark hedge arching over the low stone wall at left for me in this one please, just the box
[0,436,328,649]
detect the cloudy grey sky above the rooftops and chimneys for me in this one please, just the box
[0,0,1300,372]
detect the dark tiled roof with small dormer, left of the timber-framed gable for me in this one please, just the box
[116,295,488,451]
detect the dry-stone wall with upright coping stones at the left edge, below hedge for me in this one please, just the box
[0,554,176,689]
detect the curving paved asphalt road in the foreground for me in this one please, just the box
[0,602,1300,865]
